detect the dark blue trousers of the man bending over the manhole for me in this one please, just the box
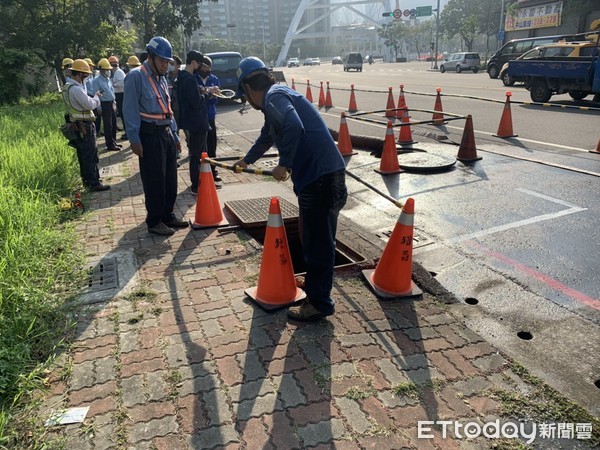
[298,169,348,314]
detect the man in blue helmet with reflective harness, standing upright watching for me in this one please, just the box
[123,36,188,236]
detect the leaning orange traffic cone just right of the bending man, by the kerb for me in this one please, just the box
[362,198,423,299]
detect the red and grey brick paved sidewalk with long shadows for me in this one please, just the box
[39,130,596,450]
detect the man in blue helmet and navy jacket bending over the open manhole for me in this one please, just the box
[236,57,348,322]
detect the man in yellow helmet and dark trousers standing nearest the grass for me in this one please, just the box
[63,59,110,192]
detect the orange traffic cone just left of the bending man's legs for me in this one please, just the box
[244,197,306,311]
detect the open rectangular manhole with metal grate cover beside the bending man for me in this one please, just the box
[225,197,366,274]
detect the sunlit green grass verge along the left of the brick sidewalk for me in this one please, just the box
[0,94,83,448]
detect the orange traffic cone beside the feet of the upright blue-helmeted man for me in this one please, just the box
[192,152,228,230]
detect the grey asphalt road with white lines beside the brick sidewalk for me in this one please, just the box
[219,63,600,414]
